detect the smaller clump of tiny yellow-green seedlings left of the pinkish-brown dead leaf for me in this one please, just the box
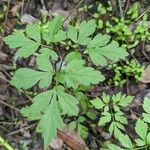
[109,59,144,86]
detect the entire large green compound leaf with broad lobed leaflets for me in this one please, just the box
[4,16,128,149]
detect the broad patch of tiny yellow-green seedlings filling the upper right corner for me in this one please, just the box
[84,1,150,49]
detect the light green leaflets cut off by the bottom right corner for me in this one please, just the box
[107,97,150,150]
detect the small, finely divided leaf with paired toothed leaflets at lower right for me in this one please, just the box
[91,93,133,135]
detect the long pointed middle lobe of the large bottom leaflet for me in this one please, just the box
[37,95,63,150]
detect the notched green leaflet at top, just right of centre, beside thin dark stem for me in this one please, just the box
[67,20,96,45]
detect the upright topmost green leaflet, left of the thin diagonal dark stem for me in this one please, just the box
[43,16,66,44]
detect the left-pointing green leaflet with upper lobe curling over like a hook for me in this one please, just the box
[11,48,57,89]
